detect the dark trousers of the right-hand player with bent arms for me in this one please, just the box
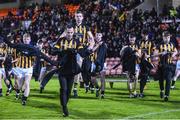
[159,65,174,96]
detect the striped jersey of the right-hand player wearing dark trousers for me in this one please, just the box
[158,43,177,64]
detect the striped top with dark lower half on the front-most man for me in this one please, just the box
[54,38,88,75]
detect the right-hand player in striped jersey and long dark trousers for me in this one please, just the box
[158,31,177,101]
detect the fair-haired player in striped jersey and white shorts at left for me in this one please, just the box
[17,33,34,105]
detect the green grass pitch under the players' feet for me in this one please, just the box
[0,78,180,119]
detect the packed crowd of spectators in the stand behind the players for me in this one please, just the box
[0,0,180,57]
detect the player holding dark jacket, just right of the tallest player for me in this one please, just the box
[90,31,107,98]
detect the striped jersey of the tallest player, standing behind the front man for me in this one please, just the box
[74,23,90,45]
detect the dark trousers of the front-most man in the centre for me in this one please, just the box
[59,75,74,106]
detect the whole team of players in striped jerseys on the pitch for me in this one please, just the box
[0,11,178,117]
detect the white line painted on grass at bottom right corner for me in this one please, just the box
[122,109,180,119]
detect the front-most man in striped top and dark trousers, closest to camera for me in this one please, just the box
[54,25,93,117]
